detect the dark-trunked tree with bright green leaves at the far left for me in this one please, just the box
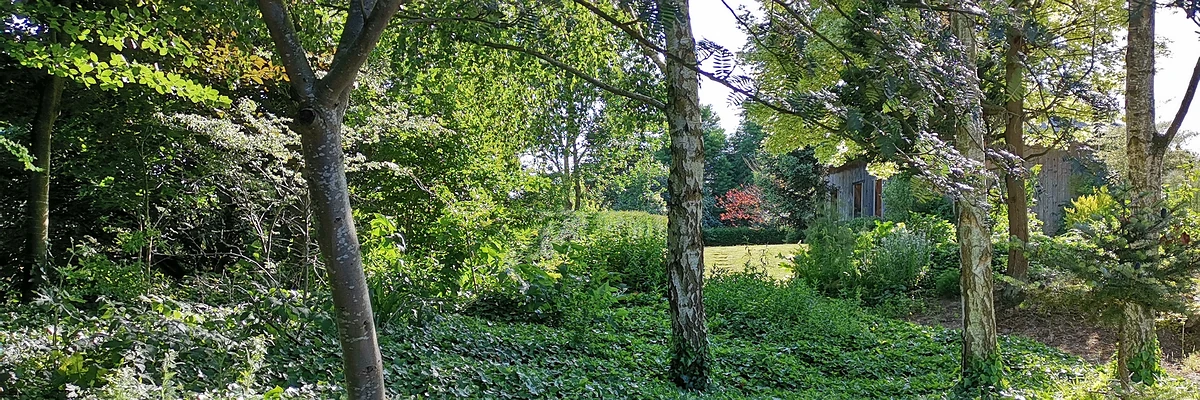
[0,1,229,300]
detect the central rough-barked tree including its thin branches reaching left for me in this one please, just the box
[444,0,712,390]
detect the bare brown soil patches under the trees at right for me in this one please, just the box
[907,294,1200,382]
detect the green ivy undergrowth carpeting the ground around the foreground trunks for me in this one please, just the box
[0,273,1198,399]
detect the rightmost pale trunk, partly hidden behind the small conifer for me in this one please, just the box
[1117,0,1166,388]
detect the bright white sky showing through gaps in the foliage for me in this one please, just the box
[691,0,1200,147]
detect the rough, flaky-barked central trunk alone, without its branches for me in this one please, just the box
[659,0,709,390]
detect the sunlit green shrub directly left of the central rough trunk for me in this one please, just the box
[466,211,666,327]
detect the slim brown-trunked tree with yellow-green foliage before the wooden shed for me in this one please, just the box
[980,0,1123,281]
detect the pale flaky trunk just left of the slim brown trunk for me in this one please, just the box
[950,13,1001,389]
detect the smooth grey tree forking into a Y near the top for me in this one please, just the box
[258,0,402,399]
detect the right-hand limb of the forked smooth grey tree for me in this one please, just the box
[321,0,403,102]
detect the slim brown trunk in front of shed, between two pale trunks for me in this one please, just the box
[1004,4,1030,281]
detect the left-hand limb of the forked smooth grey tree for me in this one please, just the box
[258,0,317,98]
